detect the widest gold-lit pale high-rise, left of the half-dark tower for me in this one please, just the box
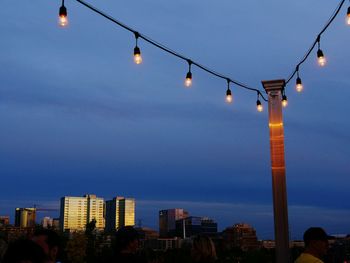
[60,195,105,231]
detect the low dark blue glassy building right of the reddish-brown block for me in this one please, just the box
[176,216,218,238]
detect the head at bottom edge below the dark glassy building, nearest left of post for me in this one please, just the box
[191,236,216,262]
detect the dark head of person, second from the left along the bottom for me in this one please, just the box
[32,228,61,261]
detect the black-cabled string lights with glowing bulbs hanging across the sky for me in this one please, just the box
[59,0,350,112]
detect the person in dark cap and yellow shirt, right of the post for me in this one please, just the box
[295,227,332,263]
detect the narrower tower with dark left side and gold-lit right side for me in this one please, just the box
[106,196,135,231]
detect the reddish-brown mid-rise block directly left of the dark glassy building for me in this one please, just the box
[159,208,188,237]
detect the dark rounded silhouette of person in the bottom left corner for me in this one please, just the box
[3,239,47,263]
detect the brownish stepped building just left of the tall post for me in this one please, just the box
[223,223,260,251]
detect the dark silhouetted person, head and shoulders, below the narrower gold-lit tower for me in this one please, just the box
[115,226,147,263]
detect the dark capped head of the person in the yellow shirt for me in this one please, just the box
[304,227,332,257]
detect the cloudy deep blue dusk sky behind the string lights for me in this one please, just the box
[0,0,350,238]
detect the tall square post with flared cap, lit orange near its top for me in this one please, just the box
[262,80,290,263]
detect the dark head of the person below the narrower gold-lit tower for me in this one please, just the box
[115,226,139,253]
